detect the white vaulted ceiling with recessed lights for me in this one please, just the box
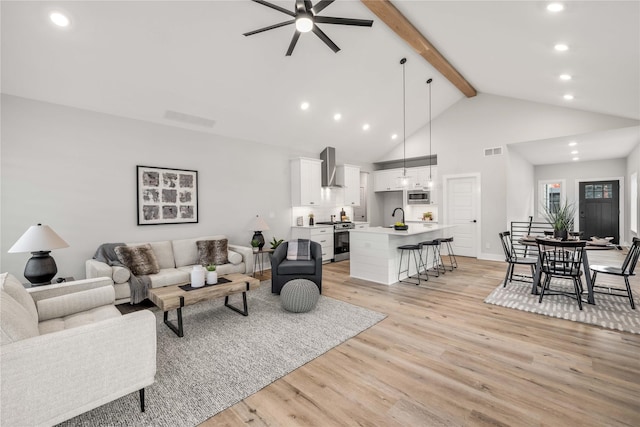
[1,0,640,162]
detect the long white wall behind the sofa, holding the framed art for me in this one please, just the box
[0,95,344,279]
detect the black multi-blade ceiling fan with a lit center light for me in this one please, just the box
[244,0,373,56]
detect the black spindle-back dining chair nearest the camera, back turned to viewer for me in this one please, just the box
[536,239,587,310]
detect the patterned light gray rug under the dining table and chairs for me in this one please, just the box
[484,279,640,334]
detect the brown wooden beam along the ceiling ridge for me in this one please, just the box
[360,0,478,98]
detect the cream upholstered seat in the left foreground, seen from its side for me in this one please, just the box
[0,273,156,426]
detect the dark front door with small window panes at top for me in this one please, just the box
[579,181,620,243]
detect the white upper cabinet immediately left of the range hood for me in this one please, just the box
[291,157,322,206]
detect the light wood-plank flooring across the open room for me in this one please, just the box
[202,251,640,427]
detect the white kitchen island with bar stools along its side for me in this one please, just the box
[349,223,455,285]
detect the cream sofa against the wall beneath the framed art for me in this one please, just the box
[85,235,253,304]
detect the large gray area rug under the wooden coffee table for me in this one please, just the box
[62,281,386,426]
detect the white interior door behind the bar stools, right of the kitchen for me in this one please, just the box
[443,175,480,257]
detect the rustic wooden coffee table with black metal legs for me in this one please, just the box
[148,273,260,337]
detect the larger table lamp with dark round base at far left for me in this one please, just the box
[9,224,69,285]
